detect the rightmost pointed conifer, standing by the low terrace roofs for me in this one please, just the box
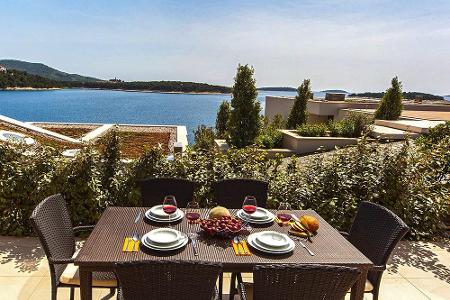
[375,76,403,120]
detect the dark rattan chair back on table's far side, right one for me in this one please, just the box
[213,178,269,208]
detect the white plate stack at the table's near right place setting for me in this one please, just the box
[247,231,295,254]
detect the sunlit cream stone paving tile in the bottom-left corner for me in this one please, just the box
[0,276,43,300]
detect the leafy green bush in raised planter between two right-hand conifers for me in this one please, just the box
[328,112,373,138]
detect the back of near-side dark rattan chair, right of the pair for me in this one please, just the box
[238,264,360,300]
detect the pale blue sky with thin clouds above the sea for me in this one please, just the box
[0,0,450,94]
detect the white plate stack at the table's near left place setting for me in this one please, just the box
[141,228,189,251]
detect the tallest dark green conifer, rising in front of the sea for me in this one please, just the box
[228,65,261,148]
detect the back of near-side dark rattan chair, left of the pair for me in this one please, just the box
[116,260,222,300]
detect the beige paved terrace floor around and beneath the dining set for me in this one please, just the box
[0,236,450,300]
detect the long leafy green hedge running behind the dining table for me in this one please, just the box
[0,130,450,239]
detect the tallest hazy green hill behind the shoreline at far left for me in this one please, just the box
[0,59,102,82]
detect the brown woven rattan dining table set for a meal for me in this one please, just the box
[75,207,372,300]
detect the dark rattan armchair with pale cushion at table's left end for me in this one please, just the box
[30,194,117,300]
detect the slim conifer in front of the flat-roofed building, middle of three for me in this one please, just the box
[287,79,312,129]
